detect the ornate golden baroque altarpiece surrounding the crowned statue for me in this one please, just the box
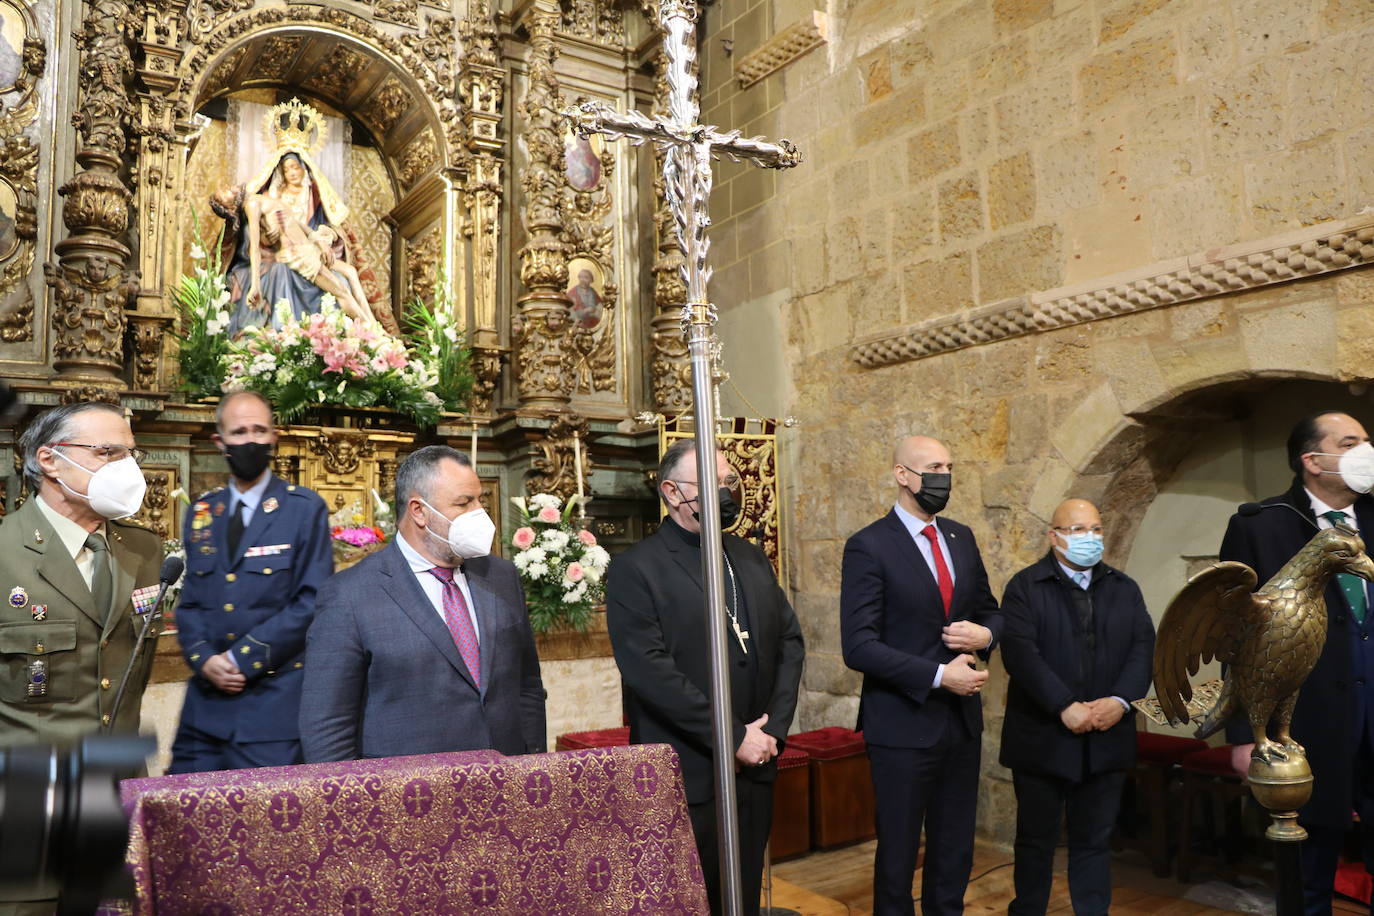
[0,0,752,560]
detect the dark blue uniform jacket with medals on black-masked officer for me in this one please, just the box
[176,475,334,743]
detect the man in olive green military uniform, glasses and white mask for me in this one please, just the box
[0,404,162,916]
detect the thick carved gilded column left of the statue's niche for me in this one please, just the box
[43,0,140,400]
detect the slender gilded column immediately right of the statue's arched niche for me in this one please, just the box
[459,0,506,416]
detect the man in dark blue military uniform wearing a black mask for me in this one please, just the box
[168,391,334,773]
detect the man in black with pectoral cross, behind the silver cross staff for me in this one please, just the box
[606,439,805,915]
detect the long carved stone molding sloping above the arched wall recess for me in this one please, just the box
[849,216,1374,369]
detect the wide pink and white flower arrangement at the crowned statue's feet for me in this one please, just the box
[173,227,474,426]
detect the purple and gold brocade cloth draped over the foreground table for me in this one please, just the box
[107,744,709,916]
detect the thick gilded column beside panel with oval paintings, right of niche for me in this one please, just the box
[514,0,576,411]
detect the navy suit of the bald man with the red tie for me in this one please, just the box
[840,511,1002,916]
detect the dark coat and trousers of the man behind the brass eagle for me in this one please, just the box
[1220,479,1374,913]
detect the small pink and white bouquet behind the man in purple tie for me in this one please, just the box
[511,493,610,633]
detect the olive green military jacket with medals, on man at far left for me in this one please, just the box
[0,496,162,747]
